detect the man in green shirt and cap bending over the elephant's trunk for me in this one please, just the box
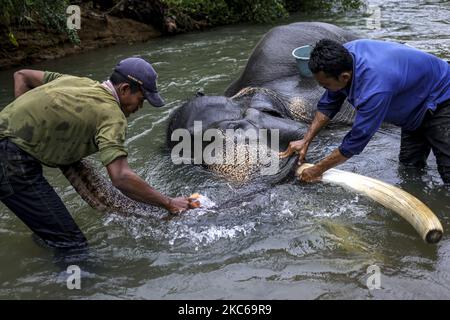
[0,58,197,248]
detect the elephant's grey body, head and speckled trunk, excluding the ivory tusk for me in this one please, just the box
[61,22,356,218]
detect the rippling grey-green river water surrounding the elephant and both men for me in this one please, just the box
[0,0,450,299]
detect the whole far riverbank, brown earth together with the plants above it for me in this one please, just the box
[0,0,358,70]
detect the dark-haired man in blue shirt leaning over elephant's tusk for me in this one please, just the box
[280,39,450,184]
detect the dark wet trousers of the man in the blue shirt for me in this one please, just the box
[399,100,450,184]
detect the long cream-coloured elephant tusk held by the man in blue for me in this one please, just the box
[296,163,443,243]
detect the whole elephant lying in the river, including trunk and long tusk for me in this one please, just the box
[61,22,443,243]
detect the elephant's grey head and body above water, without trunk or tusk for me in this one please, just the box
[167,22,357,183]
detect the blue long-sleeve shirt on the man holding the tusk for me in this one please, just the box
[317,39,450,158]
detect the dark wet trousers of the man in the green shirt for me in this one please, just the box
[0,139,87,249]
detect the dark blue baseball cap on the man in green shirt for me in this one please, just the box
[114,58,164,107]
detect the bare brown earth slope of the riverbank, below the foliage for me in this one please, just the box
[0,3,162,70]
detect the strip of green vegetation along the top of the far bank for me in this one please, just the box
[0,0,362,46]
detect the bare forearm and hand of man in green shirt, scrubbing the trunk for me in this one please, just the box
[106,157,190,213]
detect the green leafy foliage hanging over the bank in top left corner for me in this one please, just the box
[0,0,80,46]
